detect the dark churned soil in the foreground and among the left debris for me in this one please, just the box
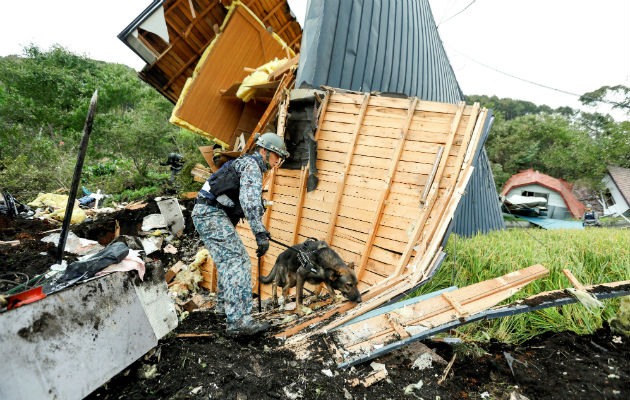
[0,205,630,400]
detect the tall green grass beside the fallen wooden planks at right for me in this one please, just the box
[414,229,630,343]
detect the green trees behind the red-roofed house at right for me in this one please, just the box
[478,89,630,191]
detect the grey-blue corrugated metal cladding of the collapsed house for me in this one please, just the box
[296,0,505,236]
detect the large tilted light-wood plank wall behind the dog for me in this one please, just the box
[230,88,487,340]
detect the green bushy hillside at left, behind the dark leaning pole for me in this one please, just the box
[0,45,208,200]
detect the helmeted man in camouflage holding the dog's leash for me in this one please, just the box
[192,132,289,336]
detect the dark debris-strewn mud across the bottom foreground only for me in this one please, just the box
[88,311,630,399]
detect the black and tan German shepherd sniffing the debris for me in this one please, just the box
[260,239,361,316]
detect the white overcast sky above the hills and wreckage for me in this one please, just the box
[0,0,630,118]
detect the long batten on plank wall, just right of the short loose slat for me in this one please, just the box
[394,101,466,275]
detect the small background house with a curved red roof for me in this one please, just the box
[501,168,585,219]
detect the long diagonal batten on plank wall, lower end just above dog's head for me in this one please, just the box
[357,97,418,280]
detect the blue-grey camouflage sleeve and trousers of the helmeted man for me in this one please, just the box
[192,153,267,328]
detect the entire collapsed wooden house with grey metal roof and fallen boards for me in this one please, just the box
[119,0,630,366]
